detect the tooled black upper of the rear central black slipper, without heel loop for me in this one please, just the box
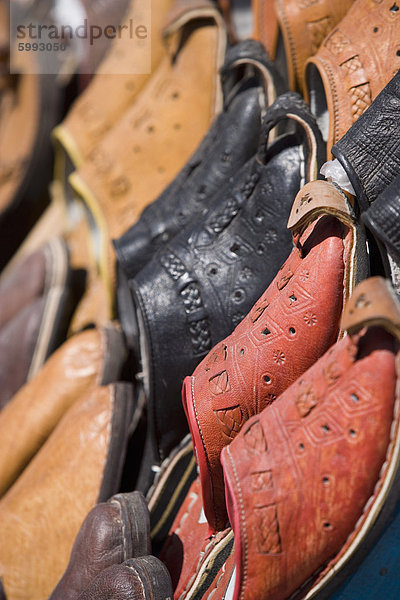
[115,44,265,277]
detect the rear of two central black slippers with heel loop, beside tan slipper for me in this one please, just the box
[114,40,281,277]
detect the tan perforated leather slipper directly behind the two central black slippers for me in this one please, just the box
[69,0,227,295]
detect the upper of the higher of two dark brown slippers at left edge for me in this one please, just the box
[0,244,46,328]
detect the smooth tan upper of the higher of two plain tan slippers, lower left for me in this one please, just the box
[0,330,107,495]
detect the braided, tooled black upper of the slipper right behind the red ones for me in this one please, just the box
[131,98,322,456]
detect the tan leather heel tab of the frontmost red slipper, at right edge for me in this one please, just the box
[342,277,400,340]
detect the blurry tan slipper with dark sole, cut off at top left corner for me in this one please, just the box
[0,2,63,271]
